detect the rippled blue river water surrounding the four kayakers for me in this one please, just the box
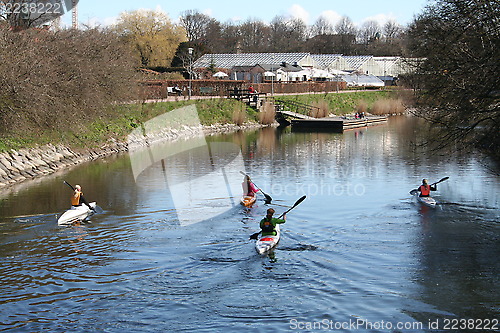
[0,118,500,332]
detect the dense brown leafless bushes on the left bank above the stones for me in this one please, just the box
[0,28,136,134]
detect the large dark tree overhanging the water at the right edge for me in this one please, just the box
[409,0,500,158]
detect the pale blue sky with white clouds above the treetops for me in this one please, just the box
[63,0,428,25]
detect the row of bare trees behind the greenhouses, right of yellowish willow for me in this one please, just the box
[180,10,405,55]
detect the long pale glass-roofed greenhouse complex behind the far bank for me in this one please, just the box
[189,53,411,86]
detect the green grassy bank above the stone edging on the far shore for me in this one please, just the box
[0,91,404,152]
